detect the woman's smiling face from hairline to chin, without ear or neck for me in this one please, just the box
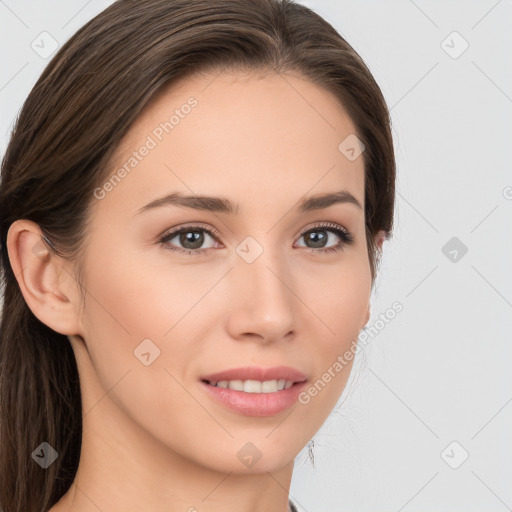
[70,73,371,473]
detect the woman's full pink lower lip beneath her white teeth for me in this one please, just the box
[201,381,306,416]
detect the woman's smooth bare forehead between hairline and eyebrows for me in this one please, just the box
[92,72,364,218]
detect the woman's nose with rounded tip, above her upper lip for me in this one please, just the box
[227,244,300,343]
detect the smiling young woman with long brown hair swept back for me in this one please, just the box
[0,0,395,512]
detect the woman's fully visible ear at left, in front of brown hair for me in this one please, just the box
[7,219,80,335]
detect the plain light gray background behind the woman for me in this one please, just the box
[0,0,512,512]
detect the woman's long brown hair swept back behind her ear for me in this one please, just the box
[0,0,395,512]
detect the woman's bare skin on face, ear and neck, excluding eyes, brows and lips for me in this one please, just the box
[8,72,382,512]
